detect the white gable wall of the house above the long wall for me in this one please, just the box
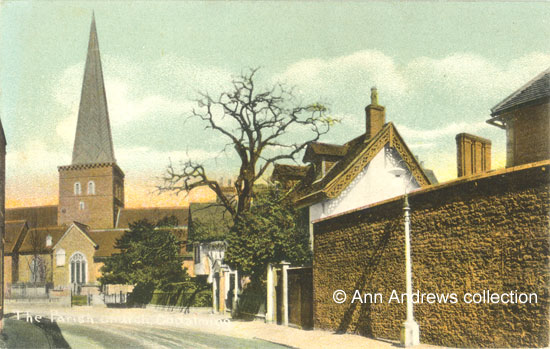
[309,146,420,237]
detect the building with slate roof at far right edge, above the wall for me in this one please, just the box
[487,68,550,167]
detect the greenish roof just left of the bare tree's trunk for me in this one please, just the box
[188,203,233,241]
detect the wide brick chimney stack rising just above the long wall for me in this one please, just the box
[456,133,491,177]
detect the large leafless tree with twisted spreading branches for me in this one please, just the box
[159,68,336,220]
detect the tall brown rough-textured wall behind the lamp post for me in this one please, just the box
[313,161,550,347]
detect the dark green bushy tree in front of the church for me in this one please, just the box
[99,218,189,304]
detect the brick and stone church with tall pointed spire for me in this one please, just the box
[4,14,188,295]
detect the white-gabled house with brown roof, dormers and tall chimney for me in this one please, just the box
[272,88,437,243]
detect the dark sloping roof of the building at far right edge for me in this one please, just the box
[491,68,550,116]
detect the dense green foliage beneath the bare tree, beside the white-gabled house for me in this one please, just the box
[225,187,312,279]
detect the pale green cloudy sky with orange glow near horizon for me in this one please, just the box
[0,1,550,207]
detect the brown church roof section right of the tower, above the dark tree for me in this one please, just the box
[116,207,188,229]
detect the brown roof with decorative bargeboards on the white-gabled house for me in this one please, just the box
[295,122,431,207]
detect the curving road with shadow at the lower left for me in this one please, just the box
[0,305,288,349]
